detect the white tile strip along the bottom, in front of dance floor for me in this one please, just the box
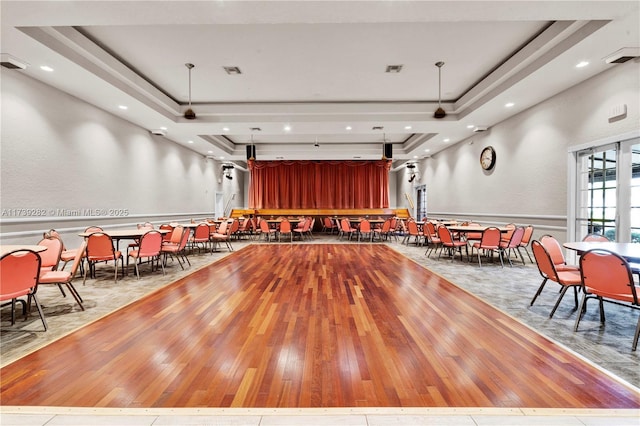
[0,407,640,426]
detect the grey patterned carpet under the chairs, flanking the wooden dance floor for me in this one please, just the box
[0,235,640,387]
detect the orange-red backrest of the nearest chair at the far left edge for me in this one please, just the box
[0,250,40,301]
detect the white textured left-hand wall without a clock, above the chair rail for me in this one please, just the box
[0,69,242,243]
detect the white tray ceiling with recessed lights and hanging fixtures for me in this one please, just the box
[0,0,640,165]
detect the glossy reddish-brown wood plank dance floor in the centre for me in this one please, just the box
[0,244,640,408]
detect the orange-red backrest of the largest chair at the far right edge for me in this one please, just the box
[580,249,638,305]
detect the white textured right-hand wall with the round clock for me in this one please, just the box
[396,61,640,243]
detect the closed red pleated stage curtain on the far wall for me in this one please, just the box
[248,160,391,209]
